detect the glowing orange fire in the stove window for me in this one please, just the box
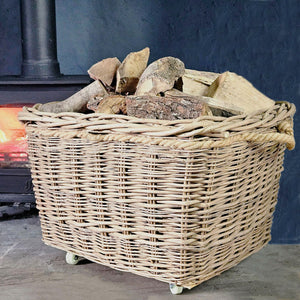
[0,103,29,168]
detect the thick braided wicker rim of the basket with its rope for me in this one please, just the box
[19,101,296,150]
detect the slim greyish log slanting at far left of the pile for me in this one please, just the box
[37,80,107,113]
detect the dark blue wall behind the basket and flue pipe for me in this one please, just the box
[0,0,300,243]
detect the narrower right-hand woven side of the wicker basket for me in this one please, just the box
[177,143,285,287]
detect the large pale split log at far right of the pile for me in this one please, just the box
[206,72,275,114]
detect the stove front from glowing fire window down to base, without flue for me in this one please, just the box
[0,103,34,218]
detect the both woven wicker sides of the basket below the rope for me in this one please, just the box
[28,133,284,287]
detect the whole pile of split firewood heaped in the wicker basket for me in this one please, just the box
[37,47,275,120]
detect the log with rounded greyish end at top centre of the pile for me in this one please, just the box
[135,56,185,96]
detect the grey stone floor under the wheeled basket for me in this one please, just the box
[0,216,300,300]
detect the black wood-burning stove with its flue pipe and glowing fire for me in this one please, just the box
[0,0,90,217]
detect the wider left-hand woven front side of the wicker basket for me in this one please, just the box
[28,133,195,282]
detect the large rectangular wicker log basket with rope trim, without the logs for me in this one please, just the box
[19,102,295,288]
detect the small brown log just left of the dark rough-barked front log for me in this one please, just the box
[88,95,126,114]
